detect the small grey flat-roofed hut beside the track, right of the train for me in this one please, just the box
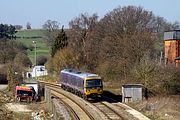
[122,84,143,103]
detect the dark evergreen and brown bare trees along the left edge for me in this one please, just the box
[0,24,32,91]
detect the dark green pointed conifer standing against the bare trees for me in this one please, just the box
[51,26,68,57]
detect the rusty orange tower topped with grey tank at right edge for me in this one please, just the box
[164,30,180,67]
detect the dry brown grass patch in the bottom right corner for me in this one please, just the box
[129,96,180,120]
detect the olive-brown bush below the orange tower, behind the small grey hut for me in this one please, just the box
[130,54,180,95]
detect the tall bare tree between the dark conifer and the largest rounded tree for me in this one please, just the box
[69,13,98,70]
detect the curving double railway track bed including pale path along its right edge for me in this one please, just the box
[39,80,149,120]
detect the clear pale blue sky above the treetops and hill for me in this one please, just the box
[0,0,180,29]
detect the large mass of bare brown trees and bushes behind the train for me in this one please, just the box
[44,6,180,94]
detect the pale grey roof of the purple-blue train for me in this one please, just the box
[61,69,100,78]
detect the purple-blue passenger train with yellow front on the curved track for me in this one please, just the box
[60,69,103,100]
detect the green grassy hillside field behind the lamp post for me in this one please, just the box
[16,30,50,63]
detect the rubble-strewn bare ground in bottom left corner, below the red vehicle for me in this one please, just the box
[0,85,52,120]
